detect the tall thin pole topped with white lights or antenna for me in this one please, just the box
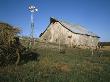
[29,5,38,46]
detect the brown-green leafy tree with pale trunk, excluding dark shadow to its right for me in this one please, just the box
[0,23,20,65]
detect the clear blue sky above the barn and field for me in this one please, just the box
[0,0,110,41]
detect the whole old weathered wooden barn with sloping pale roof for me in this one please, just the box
[40,18,100,48]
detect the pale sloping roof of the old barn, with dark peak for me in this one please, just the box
[50,18,100,38]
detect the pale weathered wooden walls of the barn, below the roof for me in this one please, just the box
[40,22,99,48]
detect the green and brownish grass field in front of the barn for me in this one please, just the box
[0,44,110,82]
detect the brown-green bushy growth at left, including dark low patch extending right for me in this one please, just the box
[0,23,39,66]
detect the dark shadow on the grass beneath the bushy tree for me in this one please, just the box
[0,49,40,67]
